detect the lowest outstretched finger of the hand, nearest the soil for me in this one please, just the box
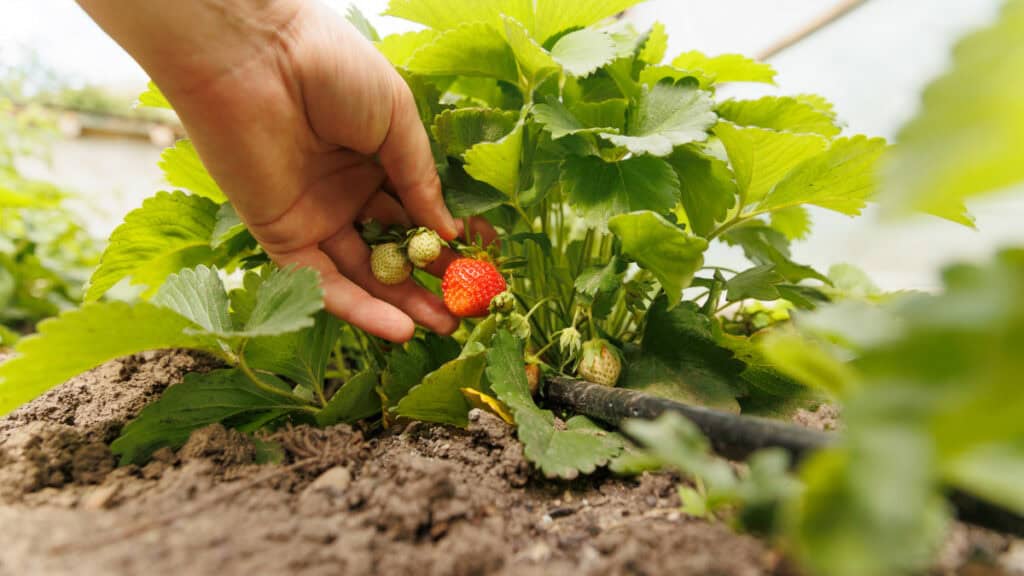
[270,246,416,342]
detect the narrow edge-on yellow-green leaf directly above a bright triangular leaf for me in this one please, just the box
[716,96,842,137]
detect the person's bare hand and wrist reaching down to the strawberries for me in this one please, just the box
[79,0,462,341]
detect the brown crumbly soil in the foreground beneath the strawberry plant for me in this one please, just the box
[0,352,1024,576]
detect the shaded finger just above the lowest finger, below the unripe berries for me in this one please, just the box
[321,227,459,334]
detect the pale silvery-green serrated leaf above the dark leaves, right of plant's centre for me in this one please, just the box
[601,83,718,156]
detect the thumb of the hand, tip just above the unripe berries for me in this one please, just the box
[379,73,459,240]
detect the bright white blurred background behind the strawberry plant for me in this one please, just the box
[0,0,1024,288]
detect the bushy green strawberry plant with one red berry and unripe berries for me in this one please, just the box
[0,0,886,471]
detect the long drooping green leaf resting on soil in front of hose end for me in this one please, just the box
[486,330,625,479]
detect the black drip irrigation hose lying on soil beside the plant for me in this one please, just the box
[545,376,1024,536]
